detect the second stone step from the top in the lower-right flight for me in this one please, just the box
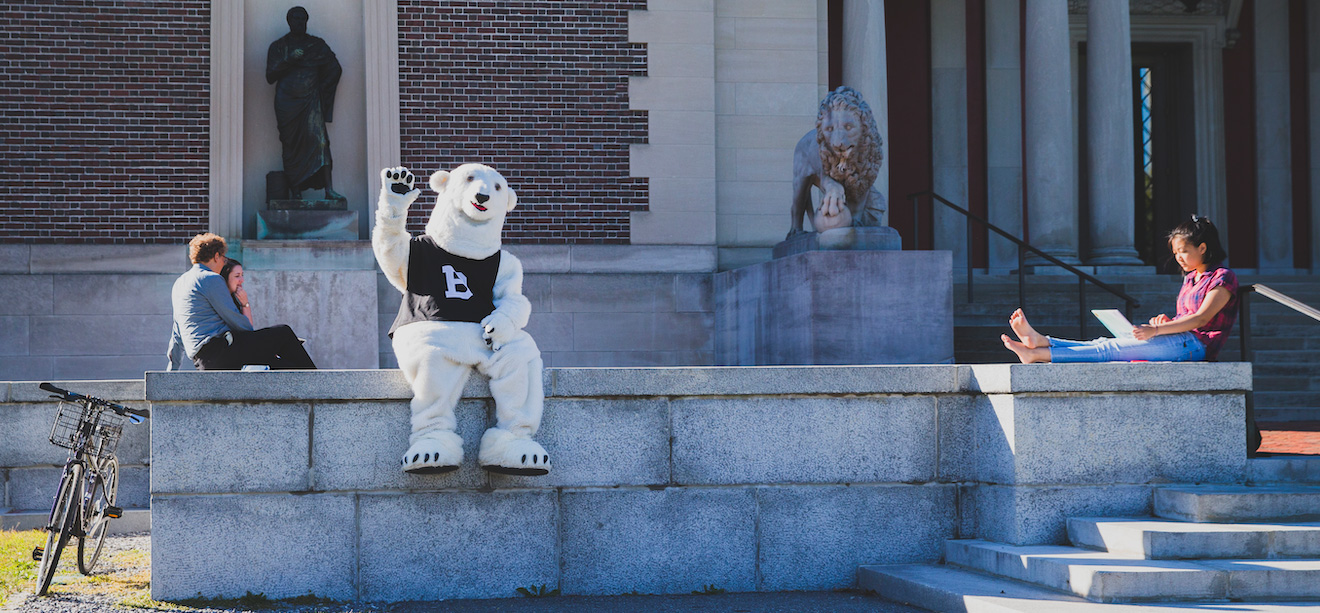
[1068,518,1320,560]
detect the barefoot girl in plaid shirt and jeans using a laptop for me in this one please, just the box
[999,215,1238,363]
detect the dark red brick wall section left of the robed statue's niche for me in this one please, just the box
[0,0,210,243]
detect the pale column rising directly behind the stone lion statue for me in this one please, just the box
[843,0,894,225]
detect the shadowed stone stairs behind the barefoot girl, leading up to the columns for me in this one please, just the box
[953,273,1320,421]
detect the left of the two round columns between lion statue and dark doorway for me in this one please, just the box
[1023,0,1078,264]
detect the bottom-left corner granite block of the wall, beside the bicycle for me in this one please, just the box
[152,494,356,600]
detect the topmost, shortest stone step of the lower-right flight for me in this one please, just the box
[1155,485,1320,523]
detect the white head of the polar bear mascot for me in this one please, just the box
[426,164,517,260]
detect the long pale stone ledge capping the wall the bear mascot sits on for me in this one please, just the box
[144,362,1251,402]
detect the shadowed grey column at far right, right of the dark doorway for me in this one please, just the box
[1251,0,1292,272]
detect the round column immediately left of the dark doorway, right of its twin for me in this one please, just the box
[1086,0,1142,266]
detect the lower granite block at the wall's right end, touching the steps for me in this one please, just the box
[970,485,1151,544]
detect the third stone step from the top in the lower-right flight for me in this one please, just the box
[945,540,1320,602]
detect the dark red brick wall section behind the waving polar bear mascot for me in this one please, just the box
[399,0,647,243]
